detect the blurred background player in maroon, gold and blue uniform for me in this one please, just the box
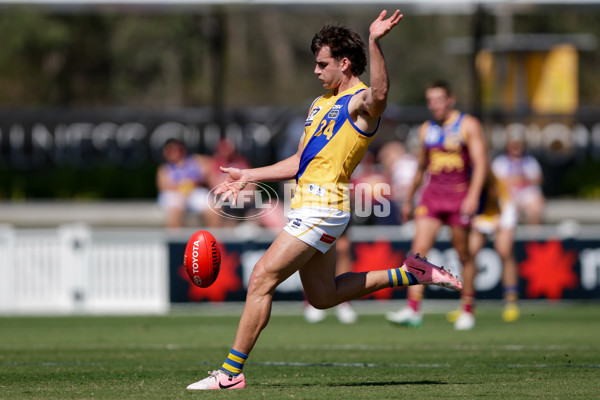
[387,81,487,330]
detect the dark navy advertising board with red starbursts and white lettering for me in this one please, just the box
[169,231,600,303]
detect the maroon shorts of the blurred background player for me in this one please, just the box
[415,190,471,228]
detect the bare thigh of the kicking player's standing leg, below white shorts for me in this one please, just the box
[248,231,317,295]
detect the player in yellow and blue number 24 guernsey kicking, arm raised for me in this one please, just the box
[187,10,462,390]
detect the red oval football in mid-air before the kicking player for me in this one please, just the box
[183,231,221,288]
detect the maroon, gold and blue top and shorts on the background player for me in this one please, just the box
[415,111,471,226]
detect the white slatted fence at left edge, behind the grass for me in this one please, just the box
[0,224,169,314]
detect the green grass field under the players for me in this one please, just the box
[0,302,600,400]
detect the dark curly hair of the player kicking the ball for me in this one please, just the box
[310,25,367,76]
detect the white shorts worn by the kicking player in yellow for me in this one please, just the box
[283,207,350,253]
